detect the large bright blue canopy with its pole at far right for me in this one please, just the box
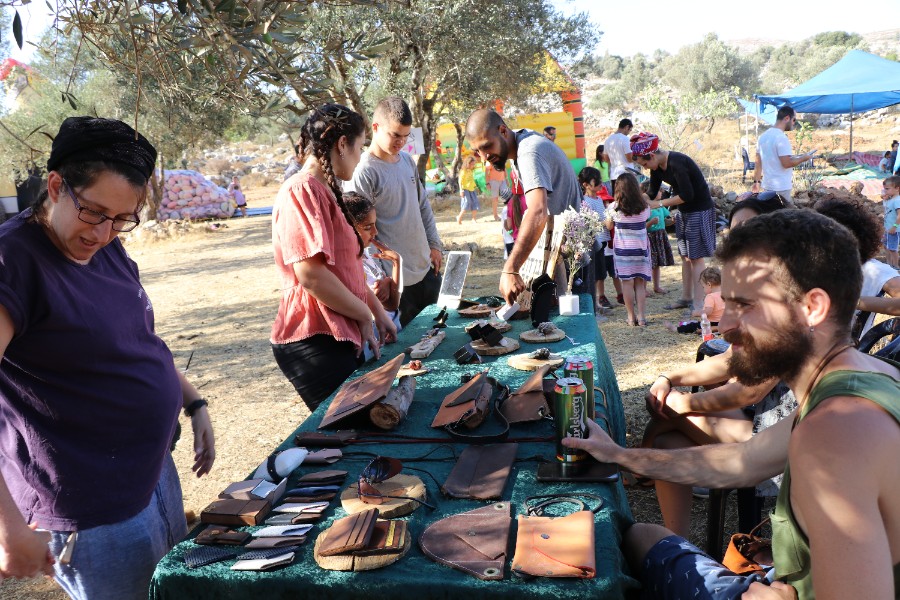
[757,50,900,153]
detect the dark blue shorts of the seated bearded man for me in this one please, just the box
[641,535,768,600]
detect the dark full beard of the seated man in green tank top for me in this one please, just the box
[723,321,813,385]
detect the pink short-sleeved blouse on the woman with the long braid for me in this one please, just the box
[271,173,368,348]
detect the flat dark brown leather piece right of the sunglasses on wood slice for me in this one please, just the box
[441,444,519,500]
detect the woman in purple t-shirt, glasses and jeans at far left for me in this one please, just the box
[0,117,215,600]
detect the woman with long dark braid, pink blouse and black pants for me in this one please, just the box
[271,104,397,411]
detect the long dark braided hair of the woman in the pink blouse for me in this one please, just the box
[300,104,366,256]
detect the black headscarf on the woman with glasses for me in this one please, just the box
[47,117,156,179]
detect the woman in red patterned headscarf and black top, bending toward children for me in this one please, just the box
[631,132,716,310]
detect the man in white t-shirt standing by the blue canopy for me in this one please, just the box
[751,106,816,206]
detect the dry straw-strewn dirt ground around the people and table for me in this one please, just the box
[10,180,744,600]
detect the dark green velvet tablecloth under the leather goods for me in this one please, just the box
[150,296,638,600]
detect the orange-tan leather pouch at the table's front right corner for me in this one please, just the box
[512,510,597,579]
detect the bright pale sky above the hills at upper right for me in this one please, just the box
[552,0,888,56]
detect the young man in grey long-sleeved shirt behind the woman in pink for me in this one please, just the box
[347,96,443,327]
